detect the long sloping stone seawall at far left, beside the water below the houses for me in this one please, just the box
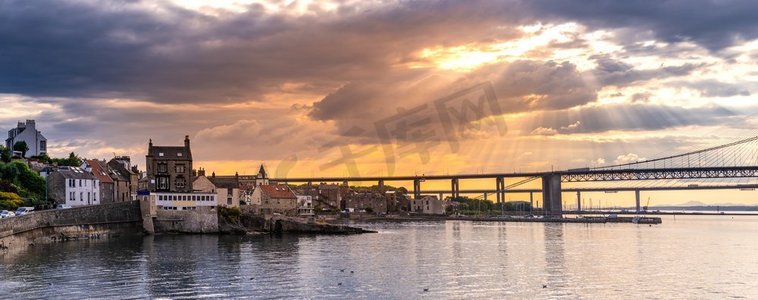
[0,201,142,253]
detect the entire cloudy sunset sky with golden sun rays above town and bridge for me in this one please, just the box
[0,0,758,202]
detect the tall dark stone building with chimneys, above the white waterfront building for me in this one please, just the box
[145,136,193,193]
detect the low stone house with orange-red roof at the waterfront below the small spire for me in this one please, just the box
[251,184,298,215]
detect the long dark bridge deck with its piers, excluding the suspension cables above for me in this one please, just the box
[218,166,758,217]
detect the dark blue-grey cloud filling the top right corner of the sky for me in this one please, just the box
[525,0,758,50]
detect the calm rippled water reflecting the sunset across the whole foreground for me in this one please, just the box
[0,216,758,299]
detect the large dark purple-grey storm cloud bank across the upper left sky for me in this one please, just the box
[0,0,532,102]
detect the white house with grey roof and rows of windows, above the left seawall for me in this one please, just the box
[47,167,101,206]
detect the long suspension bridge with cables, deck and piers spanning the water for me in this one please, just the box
[220,136,758,217]
